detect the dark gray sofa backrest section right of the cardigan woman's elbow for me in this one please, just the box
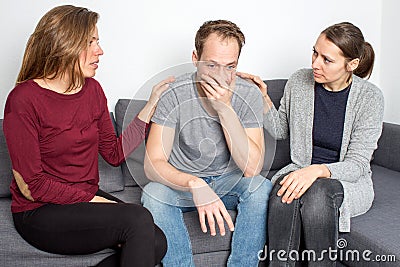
[372,122,400,171]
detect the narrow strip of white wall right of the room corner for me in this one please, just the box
[380,0,400,123]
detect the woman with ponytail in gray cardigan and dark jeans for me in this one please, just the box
[239,22,384,266]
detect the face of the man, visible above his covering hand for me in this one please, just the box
[192,33,239,84]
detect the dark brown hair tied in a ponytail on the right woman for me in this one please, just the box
[321,22,375,79]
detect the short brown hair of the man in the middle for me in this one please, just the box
[195,20,245,58]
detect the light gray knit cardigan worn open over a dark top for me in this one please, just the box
[264,69,384,232]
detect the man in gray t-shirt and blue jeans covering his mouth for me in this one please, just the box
[142,20,272,266]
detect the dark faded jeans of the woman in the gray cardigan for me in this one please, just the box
[268,175,343,267]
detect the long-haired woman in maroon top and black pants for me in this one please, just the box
[3,5,173,266]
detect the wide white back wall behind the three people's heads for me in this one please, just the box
[0,0,390,123]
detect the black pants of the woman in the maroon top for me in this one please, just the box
[13,190,167,267]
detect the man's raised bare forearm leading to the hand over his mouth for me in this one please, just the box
[219,105,264,177]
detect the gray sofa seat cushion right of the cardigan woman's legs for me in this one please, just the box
[340,165,400,266]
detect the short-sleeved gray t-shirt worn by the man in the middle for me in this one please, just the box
[152,73,263,177]
